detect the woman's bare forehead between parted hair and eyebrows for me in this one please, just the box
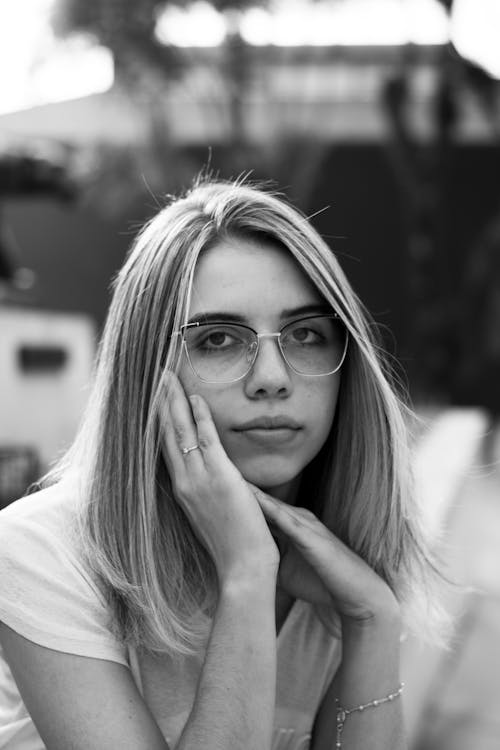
[189,238,323,319]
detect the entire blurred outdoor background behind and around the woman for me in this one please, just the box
[0,0,500,750]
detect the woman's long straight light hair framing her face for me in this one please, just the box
[48,182,448,654]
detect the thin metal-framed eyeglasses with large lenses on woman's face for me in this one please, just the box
[173,313,348,383]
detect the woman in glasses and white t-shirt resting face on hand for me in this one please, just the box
[0,182,446,750]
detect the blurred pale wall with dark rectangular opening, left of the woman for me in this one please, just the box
[0,307,95,470]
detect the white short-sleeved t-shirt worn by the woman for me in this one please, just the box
[0,485,341,750]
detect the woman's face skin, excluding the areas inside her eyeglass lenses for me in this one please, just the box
[179,238,340,502]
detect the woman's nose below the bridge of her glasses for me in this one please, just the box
[245,336,292,399]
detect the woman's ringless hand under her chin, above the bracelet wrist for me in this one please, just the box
[254,488,399,625]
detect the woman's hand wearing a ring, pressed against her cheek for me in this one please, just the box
[160,373,279,586]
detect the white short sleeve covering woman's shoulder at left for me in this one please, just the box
[0,498,128,666]
